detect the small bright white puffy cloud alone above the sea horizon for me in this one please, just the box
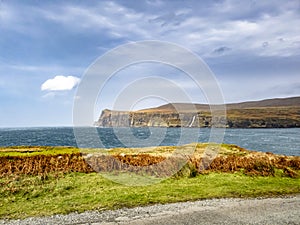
[41,76,80,91]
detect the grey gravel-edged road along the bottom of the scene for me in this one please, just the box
[0,195,300,225]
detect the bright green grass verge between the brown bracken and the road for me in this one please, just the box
[0,173,300,219]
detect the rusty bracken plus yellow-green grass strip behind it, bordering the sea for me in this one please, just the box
[0,143,300,178]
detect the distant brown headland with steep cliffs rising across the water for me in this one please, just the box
[95,97,300,128]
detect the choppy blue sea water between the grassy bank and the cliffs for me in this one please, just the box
[0,127,300,156]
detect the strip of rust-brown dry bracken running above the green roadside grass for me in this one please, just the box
[0,152,300,177]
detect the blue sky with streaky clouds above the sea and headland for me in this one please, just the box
[0,0,300,127]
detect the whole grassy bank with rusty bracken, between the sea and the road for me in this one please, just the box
[0,144,300,219]
